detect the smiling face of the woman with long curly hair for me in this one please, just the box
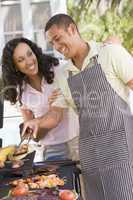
[13,43,38,77]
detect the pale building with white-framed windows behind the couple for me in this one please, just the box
[0,0,66,56]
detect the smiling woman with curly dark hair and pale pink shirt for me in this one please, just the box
[2,38,78,160]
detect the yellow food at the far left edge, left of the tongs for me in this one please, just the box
[0,145,16,168]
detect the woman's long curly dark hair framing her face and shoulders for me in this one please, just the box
[2,38,59,104]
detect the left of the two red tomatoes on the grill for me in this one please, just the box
[11,184,29,197]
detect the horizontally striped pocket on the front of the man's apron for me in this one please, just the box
[79,130,129,173]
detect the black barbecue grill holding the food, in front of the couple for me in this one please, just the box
[0,152,81,199]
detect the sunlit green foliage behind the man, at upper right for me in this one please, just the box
[67,0,133,54]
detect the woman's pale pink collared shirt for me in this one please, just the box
[21,76,79,145]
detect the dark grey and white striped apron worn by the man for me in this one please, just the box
[68,57,133,200]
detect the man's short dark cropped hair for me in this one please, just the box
[45,14,78,32]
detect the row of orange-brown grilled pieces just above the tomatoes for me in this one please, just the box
[10,174,64,189]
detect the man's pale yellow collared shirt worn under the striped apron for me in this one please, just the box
[52,41,133,110]
